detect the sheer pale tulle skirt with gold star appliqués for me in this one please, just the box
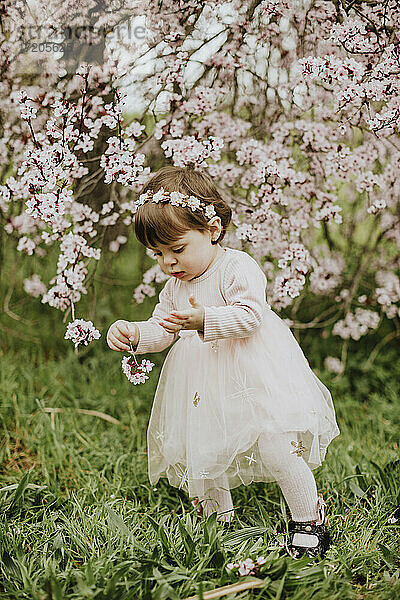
[147,304,340,497]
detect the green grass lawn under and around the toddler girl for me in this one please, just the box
[0,237,400,600]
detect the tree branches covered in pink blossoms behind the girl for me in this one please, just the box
[0,0,400,374]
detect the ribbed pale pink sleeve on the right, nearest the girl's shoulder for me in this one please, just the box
[198,256,267,342]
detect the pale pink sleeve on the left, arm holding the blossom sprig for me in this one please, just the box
[135,279,178,354]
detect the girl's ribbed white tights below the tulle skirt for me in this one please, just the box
[198,432,318,522]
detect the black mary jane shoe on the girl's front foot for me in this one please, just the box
[285,494,331,559]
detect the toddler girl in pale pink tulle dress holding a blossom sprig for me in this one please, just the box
[107,167,339,557]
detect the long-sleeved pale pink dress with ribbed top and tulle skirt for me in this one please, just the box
[137,248,340,497]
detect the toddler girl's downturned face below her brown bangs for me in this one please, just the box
[151,219,222,281]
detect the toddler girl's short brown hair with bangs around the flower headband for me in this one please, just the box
[134,166,232,247]
